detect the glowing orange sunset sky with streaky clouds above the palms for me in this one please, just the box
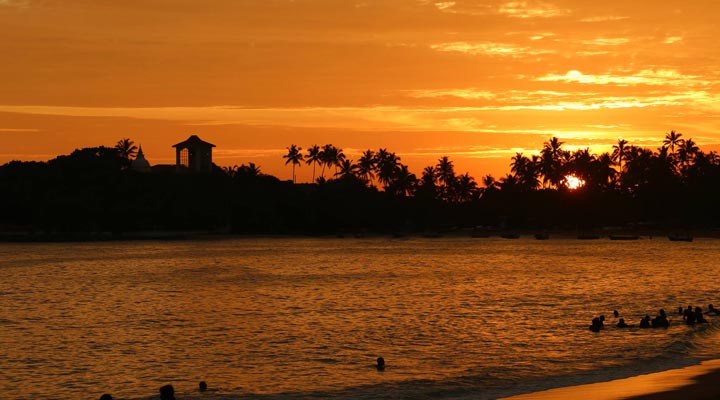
[0,0,720,181]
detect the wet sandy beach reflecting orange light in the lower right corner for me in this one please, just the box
[505,360,720,400]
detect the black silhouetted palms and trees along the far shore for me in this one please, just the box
[0,131,720,235]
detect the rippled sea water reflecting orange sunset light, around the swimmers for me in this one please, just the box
[0,237,720,399]
